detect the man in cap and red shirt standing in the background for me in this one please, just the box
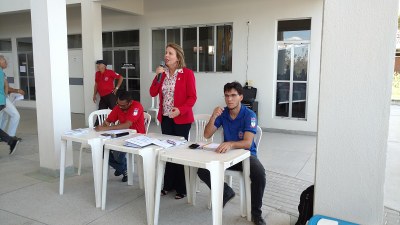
[93,60,124,109]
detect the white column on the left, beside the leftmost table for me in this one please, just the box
[31,0,72,174]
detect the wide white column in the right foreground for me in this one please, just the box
[314,0,398,225]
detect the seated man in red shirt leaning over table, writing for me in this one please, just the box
[95,91,146,182]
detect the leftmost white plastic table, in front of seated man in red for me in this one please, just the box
[60,129,136,208]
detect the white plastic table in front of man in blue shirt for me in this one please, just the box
[154,144,251,225]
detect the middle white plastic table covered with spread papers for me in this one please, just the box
[101,133,184,225]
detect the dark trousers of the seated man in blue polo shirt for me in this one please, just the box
[197,156,266,218]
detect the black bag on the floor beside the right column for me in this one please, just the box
[296,185,314,225]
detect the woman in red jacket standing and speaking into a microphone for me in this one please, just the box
[150,43,197,199]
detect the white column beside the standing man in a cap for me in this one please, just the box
[81,0,102,123]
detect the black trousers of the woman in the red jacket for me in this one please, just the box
[161,116,192,194]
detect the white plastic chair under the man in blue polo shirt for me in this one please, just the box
[208,126,262,217]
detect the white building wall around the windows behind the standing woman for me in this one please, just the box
[0,0,322,132]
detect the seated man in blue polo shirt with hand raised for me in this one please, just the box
[197,82,266,225]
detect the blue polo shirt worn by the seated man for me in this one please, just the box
[214,105,257,156]
